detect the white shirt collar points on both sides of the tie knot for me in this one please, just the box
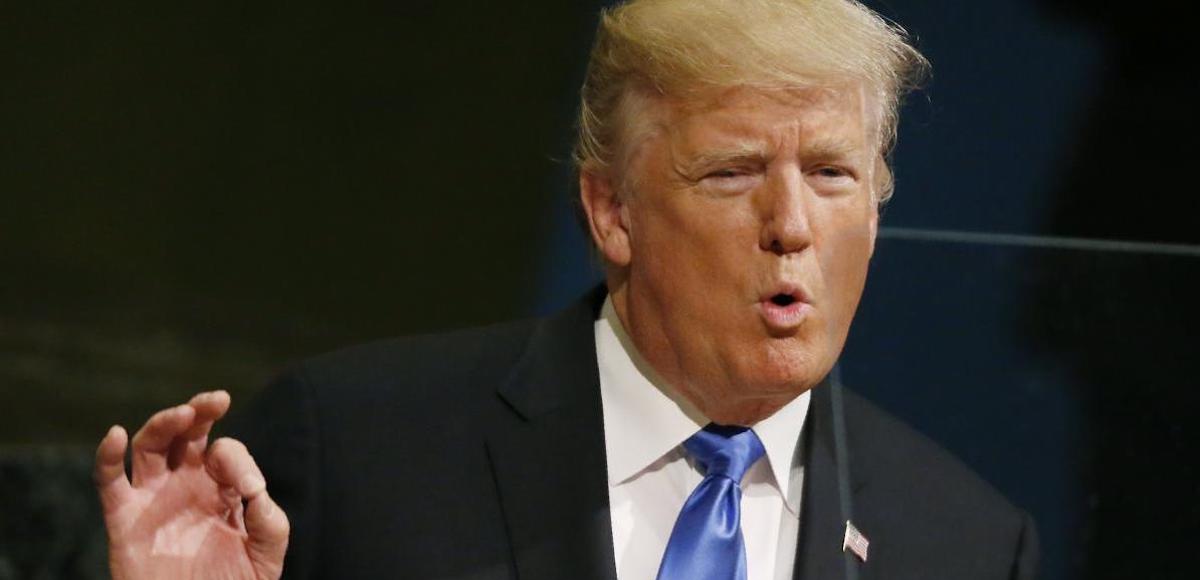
[595,298,810,512]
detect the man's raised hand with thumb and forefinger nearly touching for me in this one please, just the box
[95,390,289,580]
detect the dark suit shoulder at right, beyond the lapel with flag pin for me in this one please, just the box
[845,393,1037,578]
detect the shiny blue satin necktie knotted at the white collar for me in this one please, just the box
[658,424,764,580]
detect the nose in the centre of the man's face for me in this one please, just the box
[758,165,812,256]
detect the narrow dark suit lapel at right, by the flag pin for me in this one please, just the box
[793,382,870,580]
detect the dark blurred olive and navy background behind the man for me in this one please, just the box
[0,0,1200,580]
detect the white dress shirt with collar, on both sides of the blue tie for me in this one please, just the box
[595,299,809,580]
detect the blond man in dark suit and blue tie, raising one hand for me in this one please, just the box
[97,0,1037,580]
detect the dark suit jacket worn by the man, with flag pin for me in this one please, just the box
[235,292,1037,580]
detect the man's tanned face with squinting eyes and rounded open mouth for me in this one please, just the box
[584,84,881,424]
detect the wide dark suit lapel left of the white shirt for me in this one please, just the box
[487,289,617,580]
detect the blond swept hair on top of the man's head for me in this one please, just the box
[575,0,929,201]
